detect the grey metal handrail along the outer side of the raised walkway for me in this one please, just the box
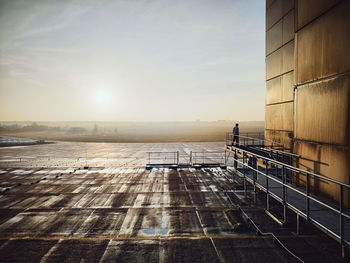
[226,146,350,253]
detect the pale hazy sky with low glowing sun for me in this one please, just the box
[0,0,265,121]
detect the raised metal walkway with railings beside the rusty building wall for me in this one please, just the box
[226,133,350,254]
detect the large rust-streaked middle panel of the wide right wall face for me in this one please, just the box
[295,74,350,146]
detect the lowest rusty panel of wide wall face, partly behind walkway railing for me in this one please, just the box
[293,141,350,206]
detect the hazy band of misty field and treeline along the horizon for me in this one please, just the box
[0,121,264,142]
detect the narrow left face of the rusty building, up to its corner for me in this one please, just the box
[265,0,295,151]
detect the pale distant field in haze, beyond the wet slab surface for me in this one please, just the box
[0,122,264,142]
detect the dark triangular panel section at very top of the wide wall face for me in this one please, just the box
[297,0,346,29]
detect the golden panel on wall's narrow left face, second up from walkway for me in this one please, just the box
[265,102,293,131]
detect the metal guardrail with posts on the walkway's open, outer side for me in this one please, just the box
[226,145,350,256]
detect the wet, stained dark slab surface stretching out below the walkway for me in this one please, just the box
[0,143,330,262]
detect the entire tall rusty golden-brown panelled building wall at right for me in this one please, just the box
[265,0,350,205]
